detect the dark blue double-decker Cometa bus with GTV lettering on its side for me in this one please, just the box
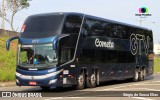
[6,13,154,89]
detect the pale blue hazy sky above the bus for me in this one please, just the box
[0,0,160,43]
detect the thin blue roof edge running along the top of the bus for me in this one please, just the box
[28,12,151,31]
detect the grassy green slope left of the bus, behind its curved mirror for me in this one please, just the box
[0,37,17,82]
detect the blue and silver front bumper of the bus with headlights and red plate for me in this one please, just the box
[16,69,63,86]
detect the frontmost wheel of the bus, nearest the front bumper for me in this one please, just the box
[75,73,85,90]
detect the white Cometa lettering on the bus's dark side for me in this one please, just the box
[95,38,114,48]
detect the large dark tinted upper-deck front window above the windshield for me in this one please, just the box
[21,15,64,38]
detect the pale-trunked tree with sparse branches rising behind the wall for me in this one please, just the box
[5,0,29,31]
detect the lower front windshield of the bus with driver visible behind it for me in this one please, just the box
[18,43,57,67]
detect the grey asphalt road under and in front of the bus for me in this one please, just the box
[0,74,160,100]
